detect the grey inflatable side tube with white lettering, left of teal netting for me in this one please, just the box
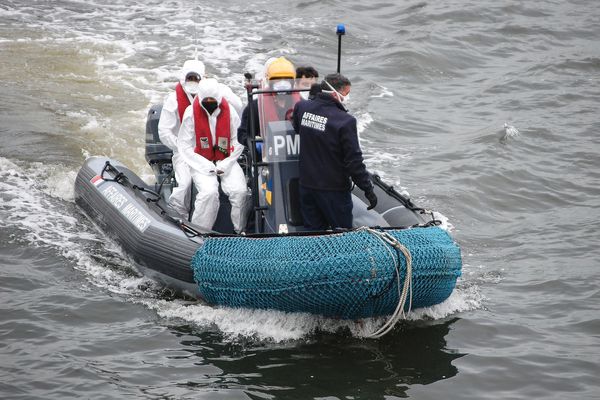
[75,157,202,288]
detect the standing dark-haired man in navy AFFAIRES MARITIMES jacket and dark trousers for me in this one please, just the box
[292,73,377,230]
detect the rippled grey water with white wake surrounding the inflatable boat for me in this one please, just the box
[0,0,600,399]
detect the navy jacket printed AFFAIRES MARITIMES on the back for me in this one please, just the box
[292,93,373,192]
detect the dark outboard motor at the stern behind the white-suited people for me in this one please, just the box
[146,104,174,198]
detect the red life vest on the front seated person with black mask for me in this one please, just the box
[192,96,233,161]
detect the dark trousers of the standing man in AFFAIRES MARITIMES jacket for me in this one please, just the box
[300,185,352,230]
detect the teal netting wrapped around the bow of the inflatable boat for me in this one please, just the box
[192,227,461,319]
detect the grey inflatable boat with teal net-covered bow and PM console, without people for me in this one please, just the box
[75,79,461,326]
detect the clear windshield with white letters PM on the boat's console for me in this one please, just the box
[257,79,309,163]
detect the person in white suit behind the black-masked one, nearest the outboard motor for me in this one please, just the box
[158,60,242,220]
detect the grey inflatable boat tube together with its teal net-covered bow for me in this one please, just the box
[75,157,461,319]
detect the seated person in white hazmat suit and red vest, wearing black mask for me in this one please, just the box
[177,79,248,233]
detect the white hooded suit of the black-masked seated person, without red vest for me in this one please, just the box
[177,79,248,232]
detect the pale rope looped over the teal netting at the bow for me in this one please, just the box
[359,227,412,339]
